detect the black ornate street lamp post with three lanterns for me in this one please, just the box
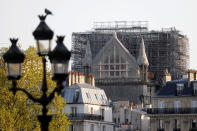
[3,10,71,131]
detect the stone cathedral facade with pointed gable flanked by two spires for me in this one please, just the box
[83,33,151,104]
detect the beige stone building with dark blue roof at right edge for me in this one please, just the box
[148,71,197,131]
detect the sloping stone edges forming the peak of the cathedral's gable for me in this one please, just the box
[93,32,137,63]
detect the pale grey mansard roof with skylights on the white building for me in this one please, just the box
[62,83,109,105]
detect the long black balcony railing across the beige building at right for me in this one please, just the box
[147,108,197,114]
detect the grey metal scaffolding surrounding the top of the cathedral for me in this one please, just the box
[72,21,189,80]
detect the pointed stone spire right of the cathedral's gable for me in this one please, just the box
[137,38,149,66]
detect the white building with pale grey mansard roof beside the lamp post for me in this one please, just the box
[62,83,114,131]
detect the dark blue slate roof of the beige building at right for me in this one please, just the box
[155,80,197,97]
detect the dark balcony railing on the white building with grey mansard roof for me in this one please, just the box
[68,113,104,121]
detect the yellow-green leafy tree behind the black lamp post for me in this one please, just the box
[0,47,70,131]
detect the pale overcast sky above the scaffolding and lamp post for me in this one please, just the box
[0,0,197,69]
